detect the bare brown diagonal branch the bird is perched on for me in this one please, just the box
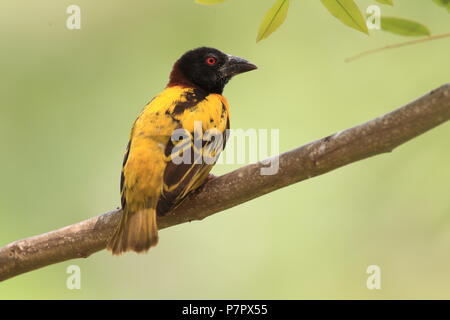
[0,83,450,281]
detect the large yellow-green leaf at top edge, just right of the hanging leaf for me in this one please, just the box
[321,0,369,34]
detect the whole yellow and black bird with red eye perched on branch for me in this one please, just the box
[107,47,257,255]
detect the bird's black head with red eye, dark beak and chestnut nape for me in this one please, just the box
[169,47,256,94]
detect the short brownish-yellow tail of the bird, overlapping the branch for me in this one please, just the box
[106,208,158,255]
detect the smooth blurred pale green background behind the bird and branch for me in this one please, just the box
[0,0,450,299]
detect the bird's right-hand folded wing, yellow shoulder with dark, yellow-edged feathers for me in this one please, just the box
[157,89,230,215]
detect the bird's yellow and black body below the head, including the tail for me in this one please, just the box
[110,86,230,252]
